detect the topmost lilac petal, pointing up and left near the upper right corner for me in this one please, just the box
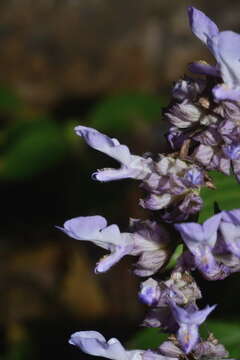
[188,7,219,50]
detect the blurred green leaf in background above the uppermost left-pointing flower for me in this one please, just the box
[88,93,166,133]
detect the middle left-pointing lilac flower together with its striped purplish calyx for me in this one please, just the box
[58,216,171,276]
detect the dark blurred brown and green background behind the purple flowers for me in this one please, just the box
[0,0,240,360]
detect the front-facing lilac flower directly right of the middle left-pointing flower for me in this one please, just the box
[175,214,221,279]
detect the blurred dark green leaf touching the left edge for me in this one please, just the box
[0,119,67,180]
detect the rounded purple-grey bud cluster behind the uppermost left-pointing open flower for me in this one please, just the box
[140,155,205,222]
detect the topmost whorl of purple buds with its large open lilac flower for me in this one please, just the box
[165,8,240,182]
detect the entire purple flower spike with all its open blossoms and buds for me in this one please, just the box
[59,8,240,360]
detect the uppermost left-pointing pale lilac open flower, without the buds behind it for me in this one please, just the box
[75,126,152,181]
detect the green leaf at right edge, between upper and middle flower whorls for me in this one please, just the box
[199,171,240,222]
